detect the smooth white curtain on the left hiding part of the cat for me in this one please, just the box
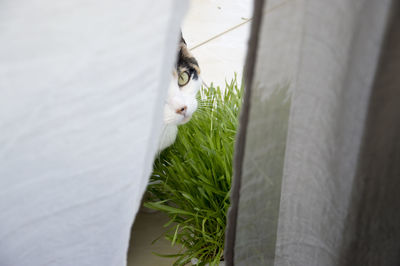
[0,0,187,266]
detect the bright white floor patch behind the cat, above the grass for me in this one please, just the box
[182,0,253,86]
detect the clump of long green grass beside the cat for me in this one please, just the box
[145,79,243,265]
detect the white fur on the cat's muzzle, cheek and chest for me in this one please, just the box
[158,75,201,151]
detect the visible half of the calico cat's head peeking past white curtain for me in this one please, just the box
[164,36,202,125]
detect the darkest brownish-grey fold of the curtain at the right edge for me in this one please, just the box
[341,2,400,266]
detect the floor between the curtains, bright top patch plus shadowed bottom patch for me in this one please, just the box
[128,0,253,266]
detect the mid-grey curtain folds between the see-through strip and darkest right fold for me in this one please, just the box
[275,0,390,265]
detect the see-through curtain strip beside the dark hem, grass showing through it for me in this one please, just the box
[234,1,299,265]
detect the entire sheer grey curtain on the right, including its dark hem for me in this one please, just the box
[225,0,400,266]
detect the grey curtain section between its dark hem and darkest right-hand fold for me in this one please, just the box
[234,0,391,265]
